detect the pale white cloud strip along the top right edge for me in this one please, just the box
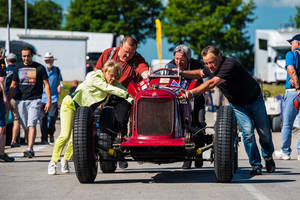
[244,0,300,7]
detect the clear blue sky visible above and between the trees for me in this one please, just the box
[48,0,300,63]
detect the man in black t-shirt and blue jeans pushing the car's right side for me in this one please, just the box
[180,46,276,175]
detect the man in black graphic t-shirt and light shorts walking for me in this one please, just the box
[8,46,51,158]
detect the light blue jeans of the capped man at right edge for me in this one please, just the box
[281,91,300,155]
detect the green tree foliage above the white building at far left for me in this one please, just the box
[0,0,63,29]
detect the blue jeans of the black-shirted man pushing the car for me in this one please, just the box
[230,95,274,166]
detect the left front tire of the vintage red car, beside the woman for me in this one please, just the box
[73,106,98,183]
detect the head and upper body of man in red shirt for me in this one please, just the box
[96,37,148,88]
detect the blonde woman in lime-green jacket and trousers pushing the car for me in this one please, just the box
[48,60,133,175]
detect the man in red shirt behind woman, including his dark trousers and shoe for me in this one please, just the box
[96,36,149,168]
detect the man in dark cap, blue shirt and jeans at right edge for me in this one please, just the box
[275,34,300,160]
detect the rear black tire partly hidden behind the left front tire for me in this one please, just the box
[98,107,117,173]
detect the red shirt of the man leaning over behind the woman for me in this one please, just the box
[96,47,149,88]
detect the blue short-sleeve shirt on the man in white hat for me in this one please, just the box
[42,66,62,103]
